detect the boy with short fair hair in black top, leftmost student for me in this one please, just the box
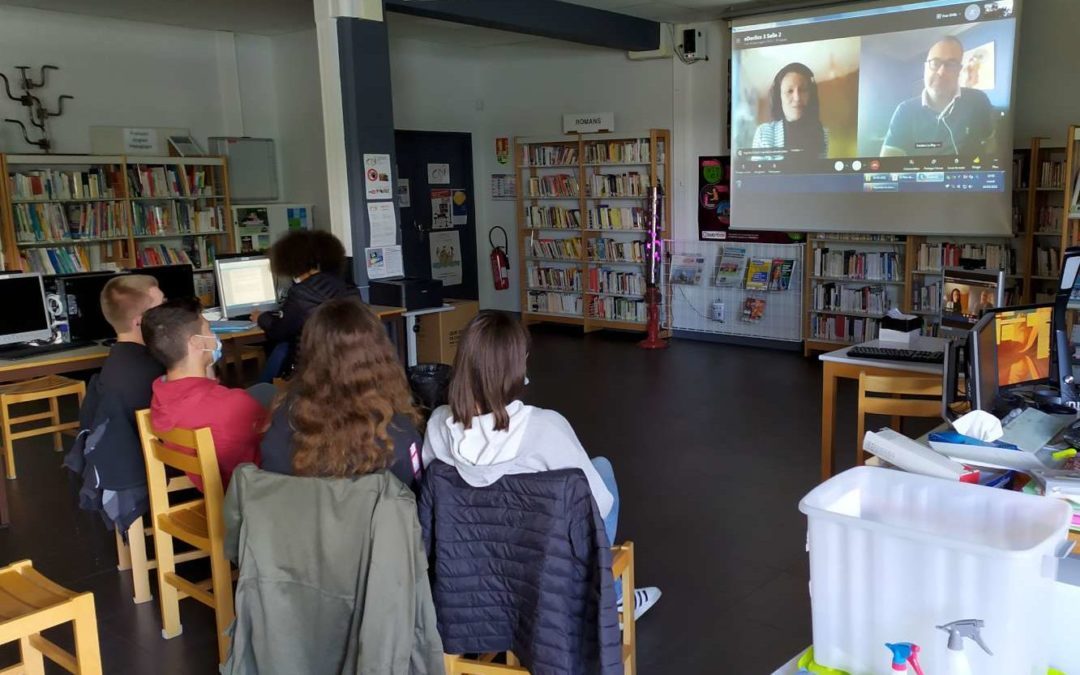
[64,274,165,531]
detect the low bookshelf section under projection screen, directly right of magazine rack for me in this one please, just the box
[802,232,913,356]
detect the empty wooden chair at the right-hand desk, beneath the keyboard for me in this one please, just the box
[855,373,943,467]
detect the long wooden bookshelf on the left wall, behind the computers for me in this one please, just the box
[0,154,234,276]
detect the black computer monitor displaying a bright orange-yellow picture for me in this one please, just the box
[969,303,1054,411]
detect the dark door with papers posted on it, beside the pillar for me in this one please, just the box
[394,131,480,300]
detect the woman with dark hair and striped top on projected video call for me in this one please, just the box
[753,63,828,157]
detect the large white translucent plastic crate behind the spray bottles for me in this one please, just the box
[799,467,1070,675]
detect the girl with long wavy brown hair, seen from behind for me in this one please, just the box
[260,298,421,492]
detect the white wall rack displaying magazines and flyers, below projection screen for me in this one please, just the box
[663,236,804,342]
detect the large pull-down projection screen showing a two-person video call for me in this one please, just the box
[730,0,1022,237]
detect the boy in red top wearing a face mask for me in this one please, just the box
[143,298,267,489]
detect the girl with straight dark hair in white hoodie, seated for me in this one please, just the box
[423,311,660,616]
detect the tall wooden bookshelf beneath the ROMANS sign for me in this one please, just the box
[514,129,671,332]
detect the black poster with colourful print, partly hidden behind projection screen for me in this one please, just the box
[698,154,802,244]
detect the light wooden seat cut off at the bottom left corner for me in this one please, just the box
[0,561,102,675]
